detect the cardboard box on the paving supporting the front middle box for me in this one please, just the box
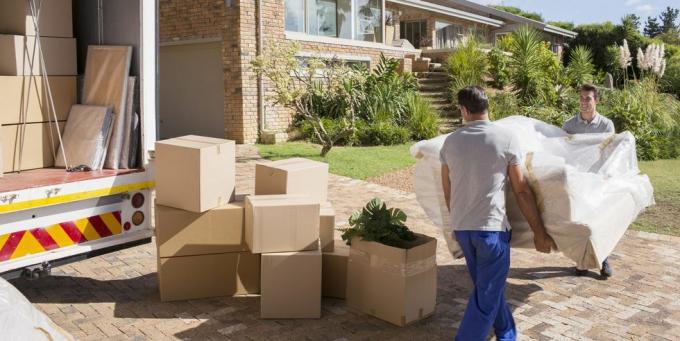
[260,250,321,319]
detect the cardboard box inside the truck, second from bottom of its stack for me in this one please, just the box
[0,76,76,124]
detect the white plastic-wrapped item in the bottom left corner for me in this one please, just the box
[0,278,73,341]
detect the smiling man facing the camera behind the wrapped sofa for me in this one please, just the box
[562,84,616,278]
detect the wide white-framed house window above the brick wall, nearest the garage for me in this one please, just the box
[284,0,384,42]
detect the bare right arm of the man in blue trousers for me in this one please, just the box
[508,165,555,253]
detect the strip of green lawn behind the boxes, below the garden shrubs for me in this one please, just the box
[257,142,416,180]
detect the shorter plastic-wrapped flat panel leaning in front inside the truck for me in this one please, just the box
[55,105,113,170]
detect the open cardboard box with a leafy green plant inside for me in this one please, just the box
[341,198,437,326]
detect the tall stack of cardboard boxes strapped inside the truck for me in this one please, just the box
[0,0,77,172]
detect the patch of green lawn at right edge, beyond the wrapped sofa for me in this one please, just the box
[631,160,680,236]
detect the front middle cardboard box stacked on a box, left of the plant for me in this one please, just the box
[245,194,319,253]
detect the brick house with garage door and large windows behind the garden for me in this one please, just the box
[159,0,576,143]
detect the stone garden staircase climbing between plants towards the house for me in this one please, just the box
[414,63,461,134]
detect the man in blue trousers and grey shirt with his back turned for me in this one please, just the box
[440,86,554,341]
